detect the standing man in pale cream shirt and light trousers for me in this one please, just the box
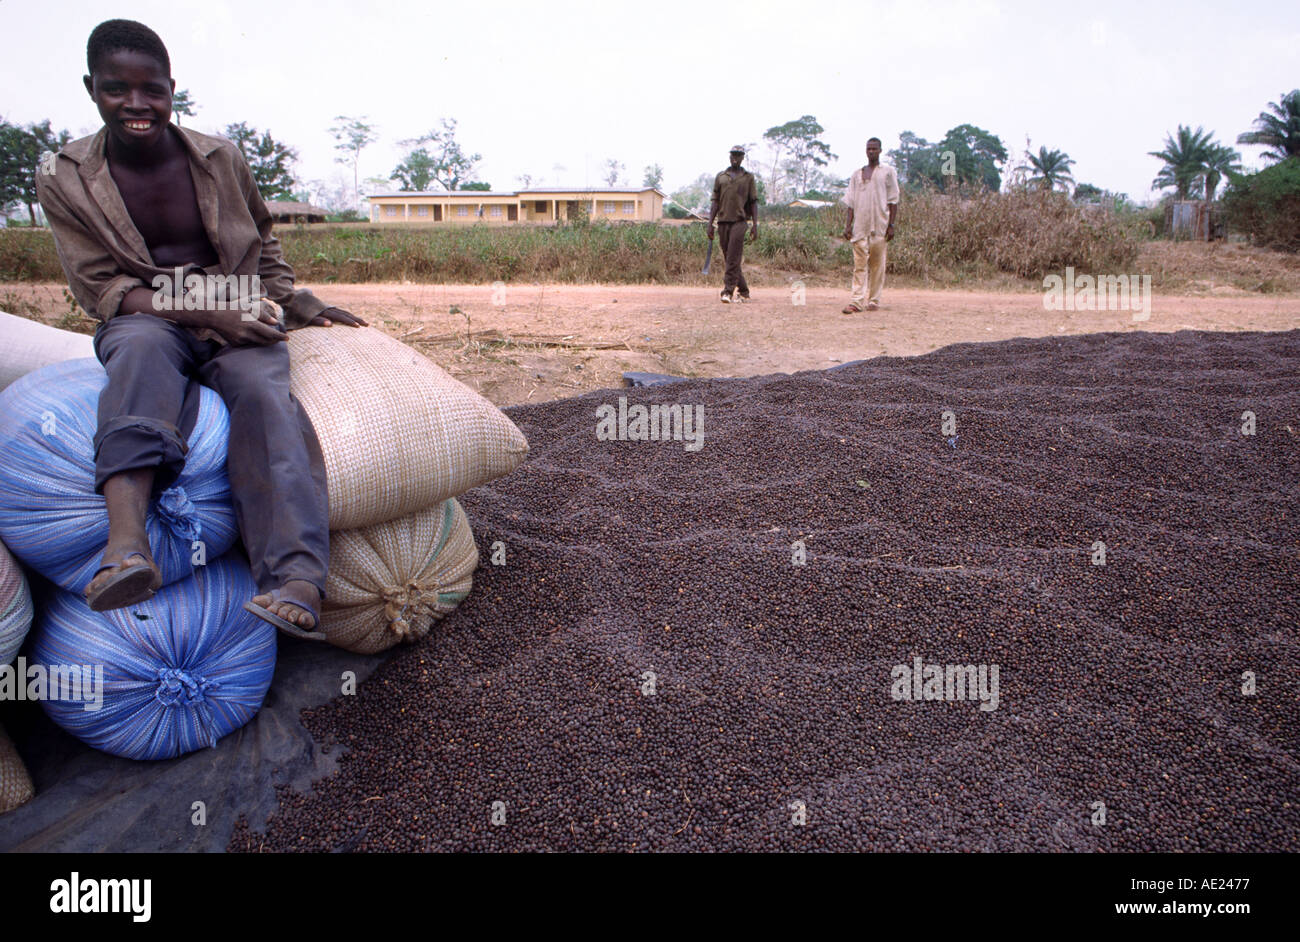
[840,138,898,314]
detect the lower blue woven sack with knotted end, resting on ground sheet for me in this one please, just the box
[27,554,276,759]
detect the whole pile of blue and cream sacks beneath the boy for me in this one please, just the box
[0,311,528,774]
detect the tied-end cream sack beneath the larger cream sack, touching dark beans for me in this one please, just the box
[321,496,478,654]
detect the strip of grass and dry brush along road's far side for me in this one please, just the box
[0,192,1139,285]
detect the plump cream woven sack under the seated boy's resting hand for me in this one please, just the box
[289,326,528,530]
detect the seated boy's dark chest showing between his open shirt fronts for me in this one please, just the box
[109,155,217,268]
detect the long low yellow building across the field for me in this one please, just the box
[369,187,664,223]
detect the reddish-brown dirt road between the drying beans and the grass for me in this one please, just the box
[0,285,1300,407]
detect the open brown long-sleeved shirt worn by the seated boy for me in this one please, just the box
[36,127,329,340]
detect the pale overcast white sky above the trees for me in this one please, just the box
[0,0,1300,200]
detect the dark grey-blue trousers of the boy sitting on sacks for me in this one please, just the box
[95,313,329,595]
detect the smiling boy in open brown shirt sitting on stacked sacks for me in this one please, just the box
[38,19,365,639]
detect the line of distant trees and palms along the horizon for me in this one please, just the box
[0,90,1300,225]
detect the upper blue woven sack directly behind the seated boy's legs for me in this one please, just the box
[0,360,238,592]
